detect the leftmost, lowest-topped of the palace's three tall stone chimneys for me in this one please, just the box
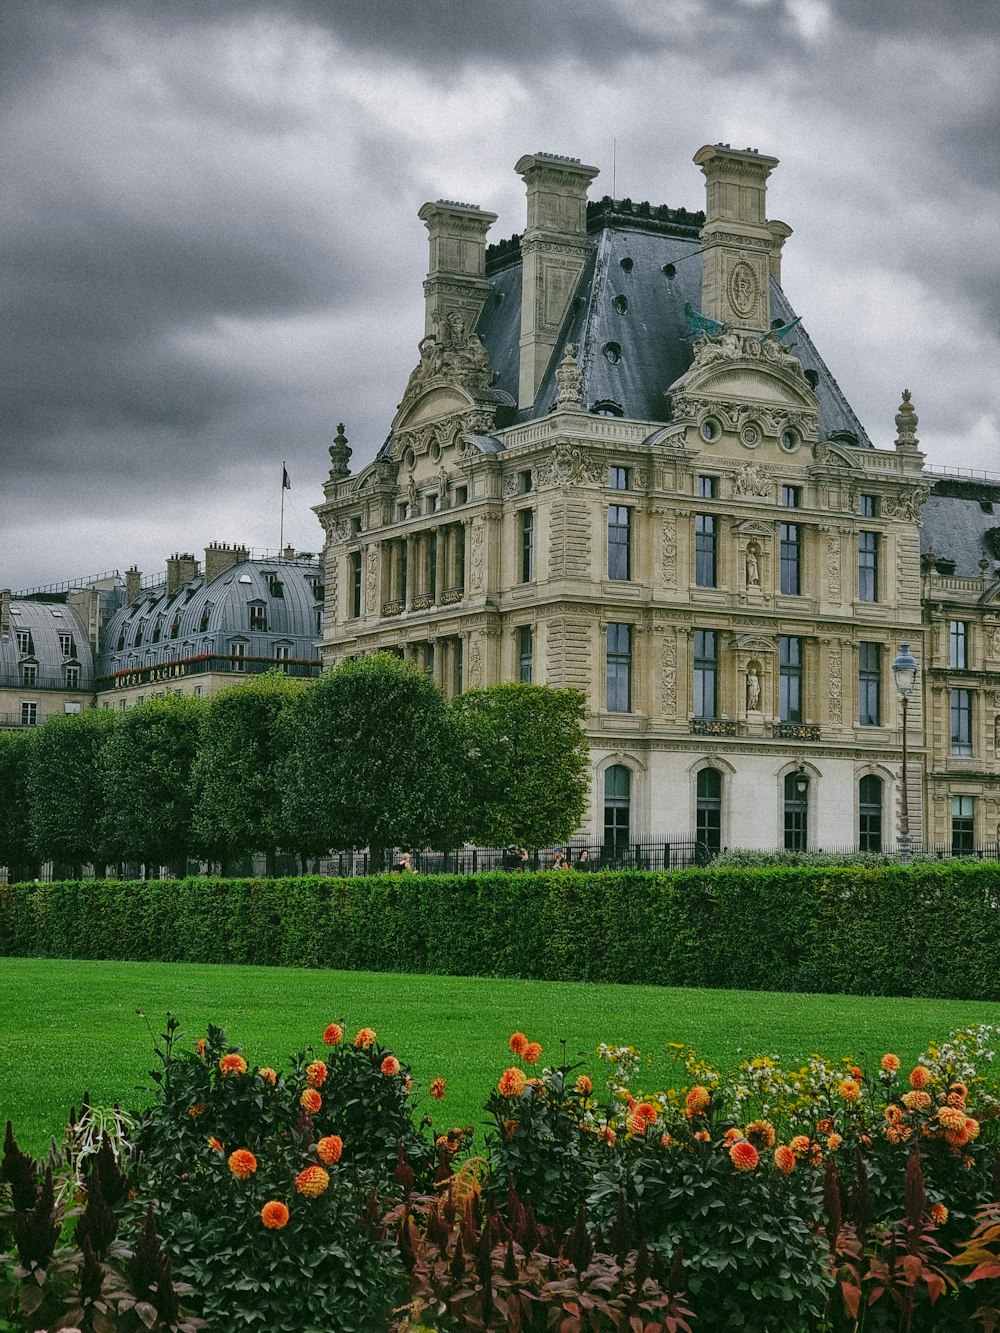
[417,199,496,336]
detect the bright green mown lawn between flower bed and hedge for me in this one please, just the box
[0,958,1000,1152]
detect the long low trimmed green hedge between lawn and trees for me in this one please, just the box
[0,861,1000,1000]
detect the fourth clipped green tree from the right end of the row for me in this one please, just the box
[103,694,207,873]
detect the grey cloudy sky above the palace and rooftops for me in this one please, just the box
[0,0,1000,588]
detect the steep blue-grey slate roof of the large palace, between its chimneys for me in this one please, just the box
[380,197,872,457]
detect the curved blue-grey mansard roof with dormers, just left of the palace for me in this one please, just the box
[96,557,323,685]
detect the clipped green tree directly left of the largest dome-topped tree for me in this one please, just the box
[192,670,307,874]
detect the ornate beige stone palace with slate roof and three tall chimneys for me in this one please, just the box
[316,145,1000,849]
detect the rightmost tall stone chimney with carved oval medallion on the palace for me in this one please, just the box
[695,144,784,333]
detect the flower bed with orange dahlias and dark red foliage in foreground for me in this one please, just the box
[0,1018,1000,1333]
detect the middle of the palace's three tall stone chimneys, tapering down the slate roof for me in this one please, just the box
[515,153,597,408]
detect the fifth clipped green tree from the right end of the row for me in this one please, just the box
[28,708,116,878]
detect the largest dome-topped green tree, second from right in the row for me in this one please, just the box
[284,653,459,857]
